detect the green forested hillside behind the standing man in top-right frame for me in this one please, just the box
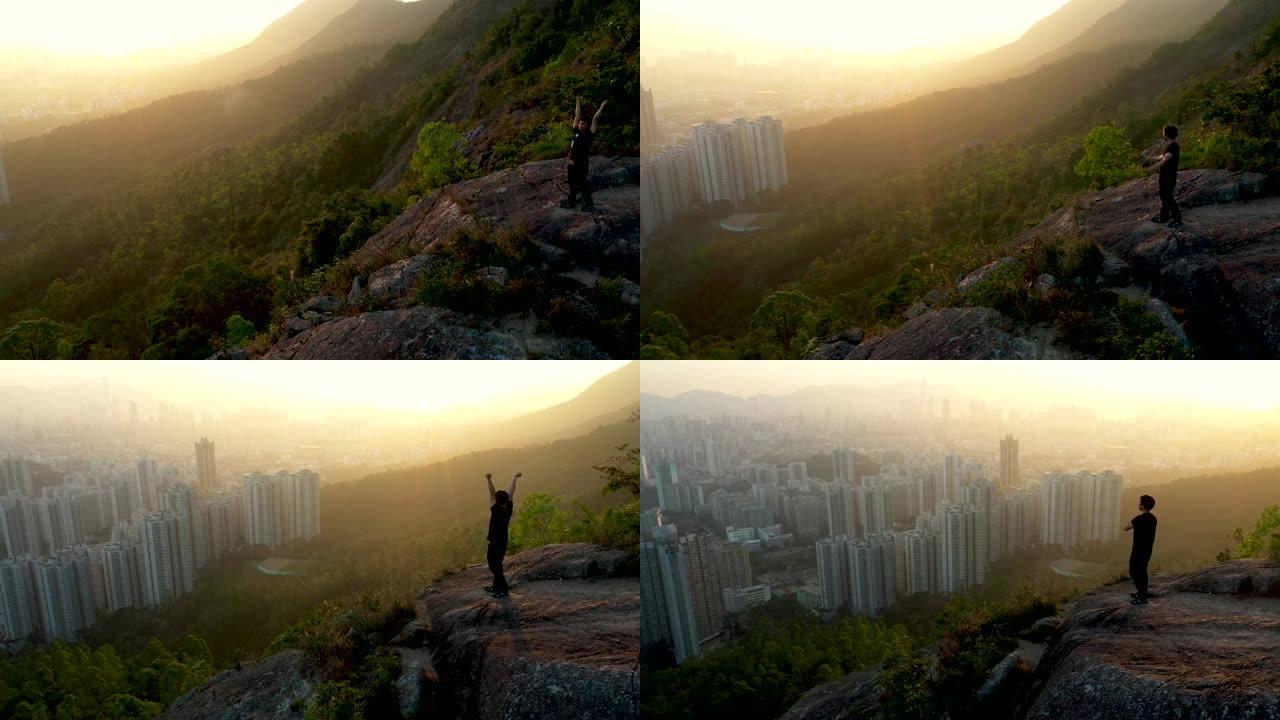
[641,0,1280,359]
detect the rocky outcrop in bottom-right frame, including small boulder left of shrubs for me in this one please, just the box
[781,560,1280,720]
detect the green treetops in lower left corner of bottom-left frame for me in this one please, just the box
[0,635,214,720]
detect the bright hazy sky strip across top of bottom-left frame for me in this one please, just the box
[0,360,626,420]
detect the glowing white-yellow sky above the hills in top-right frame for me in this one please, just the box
[640,0,1066,60]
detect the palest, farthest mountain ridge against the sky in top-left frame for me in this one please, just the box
[169,0,357,90]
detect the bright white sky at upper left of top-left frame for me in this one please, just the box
[0,0,302,55]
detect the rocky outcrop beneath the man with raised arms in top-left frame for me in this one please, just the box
[264,158,640,359]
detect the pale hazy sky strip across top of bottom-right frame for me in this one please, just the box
[640,360,1280,418]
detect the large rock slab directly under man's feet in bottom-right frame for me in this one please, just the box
[1025,560,1280,720]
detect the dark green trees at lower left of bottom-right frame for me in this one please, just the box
[640,598,913,720]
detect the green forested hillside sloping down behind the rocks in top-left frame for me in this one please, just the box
[0,0,639,359]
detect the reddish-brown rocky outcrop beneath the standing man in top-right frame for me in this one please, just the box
[810,170,1280,360]
